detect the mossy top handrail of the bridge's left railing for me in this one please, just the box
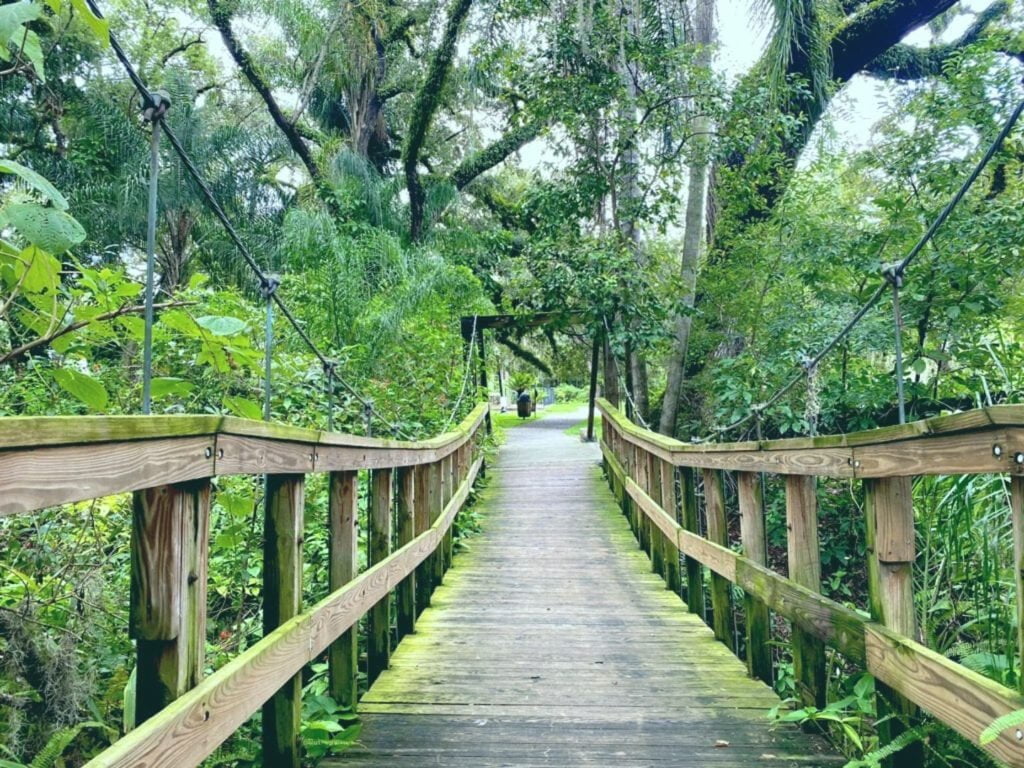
[0,403,486,517]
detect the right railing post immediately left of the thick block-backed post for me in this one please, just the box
[785,475,825,709]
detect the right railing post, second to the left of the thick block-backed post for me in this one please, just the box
[736,472,774,685]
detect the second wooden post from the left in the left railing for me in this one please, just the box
[263,474,305,768]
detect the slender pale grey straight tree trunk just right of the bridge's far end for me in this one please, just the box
[658,0,715,436]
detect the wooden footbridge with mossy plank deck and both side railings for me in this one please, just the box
[0,400,1024,768]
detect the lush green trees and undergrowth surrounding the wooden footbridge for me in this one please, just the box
[0,0,1024,765]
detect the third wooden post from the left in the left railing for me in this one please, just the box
[328,471,359,712]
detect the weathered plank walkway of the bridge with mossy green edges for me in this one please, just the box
[326,415,845,768]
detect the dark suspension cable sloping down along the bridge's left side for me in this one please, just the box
[86,0,411,439]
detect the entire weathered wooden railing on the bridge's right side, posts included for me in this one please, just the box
[598,400,1024,766]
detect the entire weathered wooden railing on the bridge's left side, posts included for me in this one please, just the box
[0,404,486,768]
